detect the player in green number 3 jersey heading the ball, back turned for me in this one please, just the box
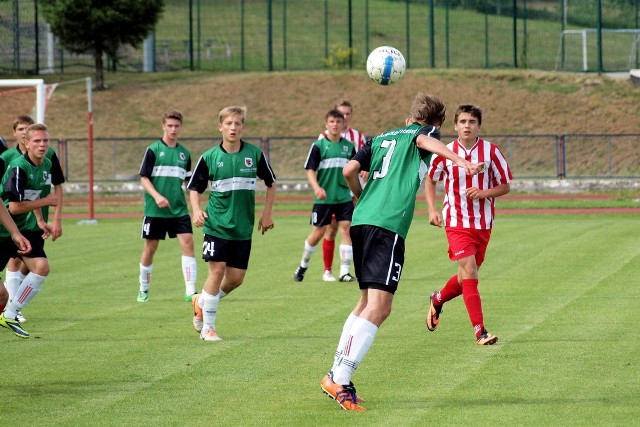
[321,94,481,411]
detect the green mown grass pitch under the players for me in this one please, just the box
[0,215,640,426]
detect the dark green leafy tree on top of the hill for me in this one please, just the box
[43,0,164,90]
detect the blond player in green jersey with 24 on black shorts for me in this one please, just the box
[187,107,276,341]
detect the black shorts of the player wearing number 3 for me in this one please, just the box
[349,225,404,294]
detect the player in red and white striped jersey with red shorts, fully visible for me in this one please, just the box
[425,104,513,345]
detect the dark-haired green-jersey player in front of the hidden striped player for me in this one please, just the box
[293,109,356,282]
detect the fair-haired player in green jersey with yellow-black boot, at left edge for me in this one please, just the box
[0,123,58,338]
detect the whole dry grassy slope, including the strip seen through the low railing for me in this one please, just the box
[0,70,640,181]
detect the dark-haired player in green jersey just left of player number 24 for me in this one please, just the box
[137,110,198,302]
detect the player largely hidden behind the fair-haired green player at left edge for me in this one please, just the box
[0,115,65,323]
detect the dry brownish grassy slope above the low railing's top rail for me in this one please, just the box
[0,70,640,138]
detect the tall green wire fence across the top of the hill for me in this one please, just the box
[0,0,640,74]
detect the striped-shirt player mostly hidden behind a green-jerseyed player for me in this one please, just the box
[318,99,367,282]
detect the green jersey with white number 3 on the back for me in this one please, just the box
[351,123,440,239]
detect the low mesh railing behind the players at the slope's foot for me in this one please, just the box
[52,134,640,183]
